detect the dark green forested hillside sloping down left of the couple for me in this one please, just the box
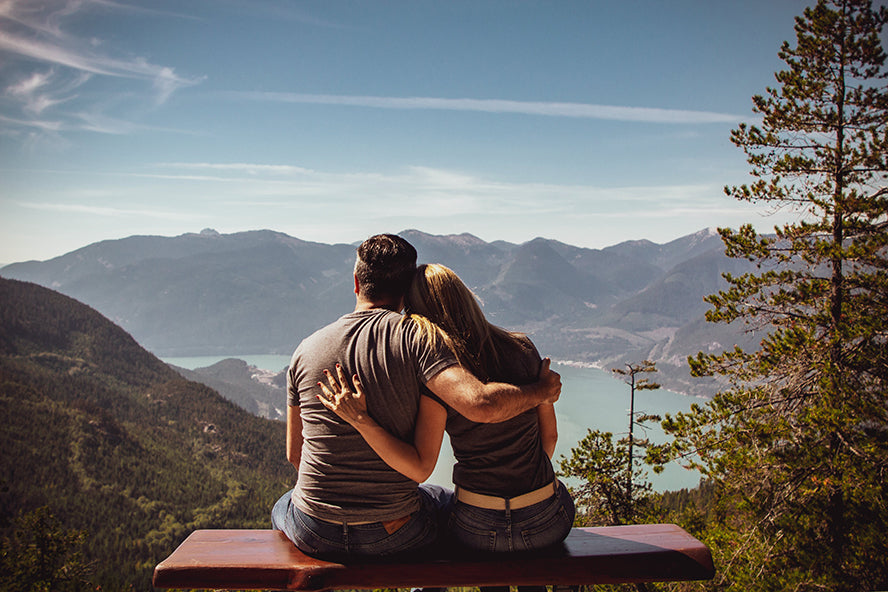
[0,279,294,590]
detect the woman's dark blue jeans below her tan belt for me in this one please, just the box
[448,485,576,553]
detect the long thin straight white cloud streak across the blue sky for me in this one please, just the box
[225,91,744,124]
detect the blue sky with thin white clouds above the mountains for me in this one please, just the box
[0,0,813,264]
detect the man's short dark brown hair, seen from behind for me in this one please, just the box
[355,234,416,301]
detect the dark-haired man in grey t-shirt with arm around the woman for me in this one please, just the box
[272,235,561,559]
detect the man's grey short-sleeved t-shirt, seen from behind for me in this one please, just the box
[287,308,457,521]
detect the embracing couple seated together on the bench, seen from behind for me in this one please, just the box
[272,230,574,580]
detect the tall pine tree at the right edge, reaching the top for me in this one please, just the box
[664,0,888,591]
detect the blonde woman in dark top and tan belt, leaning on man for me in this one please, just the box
[321,264,575,552]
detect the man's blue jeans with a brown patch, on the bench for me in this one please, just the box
[271,485,453,560]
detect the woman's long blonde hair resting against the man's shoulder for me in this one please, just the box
[404,263,518,382]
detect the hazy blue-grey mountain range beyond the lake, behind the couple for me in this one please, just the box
[0,229,752,394]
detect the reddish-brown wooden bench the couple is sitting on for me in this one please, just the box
[154,524,715,591]
